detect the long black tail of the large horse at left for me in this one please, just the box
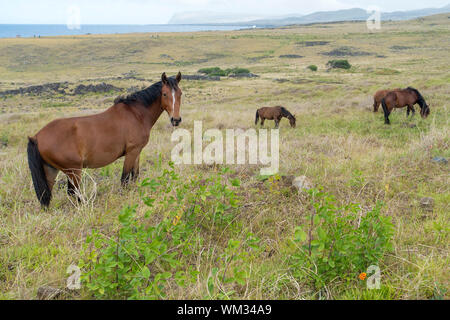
[27,137,52,207]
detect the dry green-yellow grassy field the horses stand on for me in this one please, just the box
[0,15,450,299]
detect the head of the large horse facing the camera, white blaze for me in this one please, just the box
[161,72,182,127]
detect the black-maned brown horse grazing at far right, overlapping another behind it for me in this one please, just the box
[381,87,430,124]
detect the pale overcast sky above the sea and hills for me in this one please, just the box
[0,0,450,24]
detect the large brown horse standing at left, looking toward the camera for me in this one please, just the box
[27,73,182,207]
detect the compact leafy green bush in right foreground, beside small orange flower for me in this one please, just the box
[291,189,394,288]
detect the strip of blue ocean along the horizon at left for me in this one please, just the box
[0,24,252,38]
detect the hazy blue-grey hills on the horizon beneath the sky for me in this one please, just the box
[169,4,450,26]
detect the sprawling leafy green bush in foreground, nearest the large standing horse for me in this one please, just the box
[79,164,244,299]
